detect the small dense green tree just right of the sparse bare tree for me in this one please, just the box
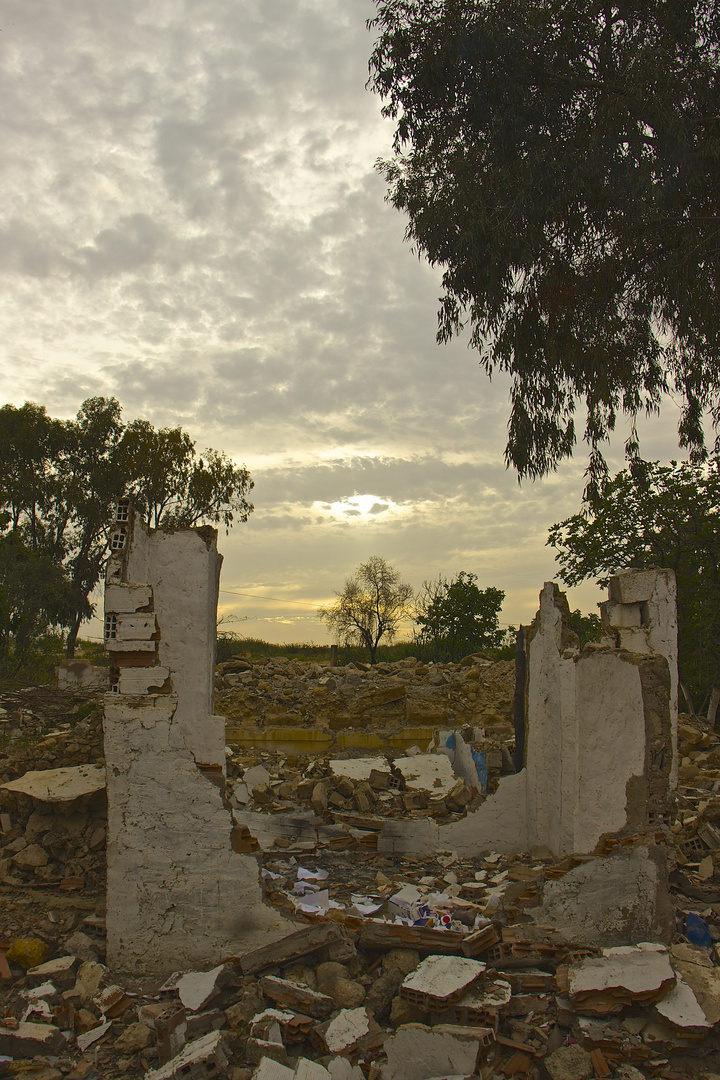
[415,570,505,660]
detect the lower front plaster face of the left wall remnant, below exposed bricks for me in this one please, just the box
[105,694,293,975]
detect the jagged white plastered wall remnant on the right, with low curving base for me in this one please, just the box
[379,570,677,856]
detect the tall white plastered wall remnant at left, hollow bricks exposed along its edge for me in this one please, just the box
[104,501,288,974]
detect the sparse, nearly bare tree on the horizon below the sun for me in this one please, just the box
[317,555,413,664]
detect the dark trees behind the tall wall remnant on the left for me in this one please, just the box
[0,397,254,674]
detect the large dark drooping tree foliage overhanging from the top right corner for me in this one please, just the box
[368,0,720,477]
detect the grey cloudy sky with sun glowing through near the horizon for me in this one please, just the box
[0,0,677,642]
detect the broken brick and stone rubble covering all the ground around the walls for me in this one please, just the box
[0,659,720,1080]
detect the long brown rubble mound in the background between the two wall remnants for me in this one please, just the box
[216,654,515,733]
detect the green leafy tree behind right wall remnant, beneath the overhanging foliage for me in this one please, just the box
[547,455,720,700]
